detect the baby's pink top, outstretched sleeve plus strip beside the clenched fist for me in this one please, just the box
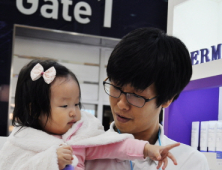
[69,139,148,170]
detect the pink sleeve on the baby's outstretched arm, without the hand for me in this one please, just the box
[85,139,148,160]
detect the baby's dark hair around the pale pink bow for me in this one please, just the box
[12,60,81,130]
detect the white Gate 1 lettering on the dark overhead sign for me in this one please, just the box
[16,0,113,27]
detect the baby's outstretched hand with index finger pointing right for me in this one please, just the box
[143,143,180,170]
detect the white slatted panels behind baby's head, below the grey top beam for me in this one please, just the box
[11,37,100,101]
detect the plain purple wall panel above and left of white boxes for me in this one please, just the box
[167,88,219,145]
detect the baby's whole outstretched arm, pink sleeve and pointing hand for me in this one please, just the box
[85,139,180,169]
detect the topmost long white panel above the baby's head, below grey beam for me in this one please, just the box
[14,37,100,64]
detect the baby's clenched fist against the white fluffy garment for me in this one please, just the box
[56,145,73,170]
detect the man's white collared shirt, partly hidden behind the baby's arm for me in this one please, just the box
[86,122,209,170]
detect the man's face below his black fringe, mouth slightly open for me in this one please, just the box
[109,82,161,135]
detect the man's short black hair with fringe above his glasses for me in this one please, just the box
[107,28,192,107]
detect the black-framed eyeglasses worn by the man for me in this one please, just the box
[103,77,158,108]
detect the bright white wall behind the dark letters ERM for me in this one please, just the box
[167,0,222,80]
